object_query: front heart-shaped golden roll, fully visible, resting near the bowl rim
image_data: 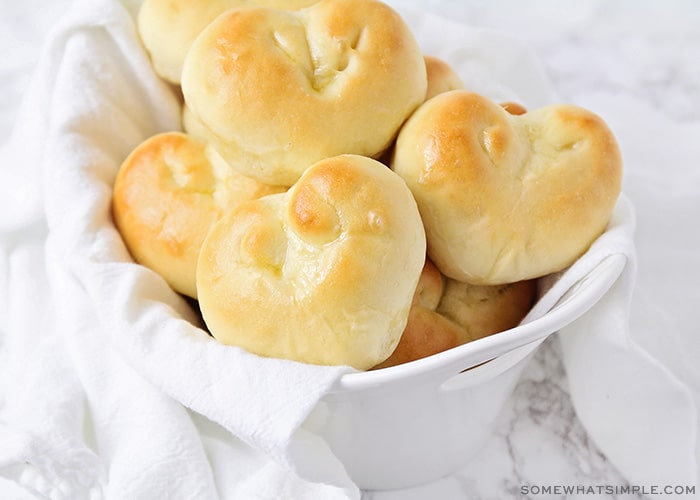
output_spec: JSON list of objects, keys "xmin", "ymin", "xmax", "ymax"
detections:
[{"xmin": 197, "ymin": 155, "xmax": 425, "ymax": 370}]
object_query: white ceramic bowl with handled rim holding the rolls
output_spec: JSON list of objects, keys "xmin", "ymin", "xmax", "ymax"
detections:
[{"xmin": 305, "ymin": 255, "xmax": 626, "ymax": 489}]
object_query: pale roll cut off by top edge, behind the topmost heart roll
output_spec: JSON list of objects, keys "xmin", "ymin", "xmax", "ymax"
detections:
[{"xmin": 137, "ymin": 0, "xmax": 318, "ymax": 84}]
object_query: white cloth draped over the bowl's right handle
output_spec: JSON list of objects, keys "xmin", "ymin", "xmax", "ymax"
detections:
[{"xmin": 523, "ymin": 195, "xmax": 697, "ymax": 498}]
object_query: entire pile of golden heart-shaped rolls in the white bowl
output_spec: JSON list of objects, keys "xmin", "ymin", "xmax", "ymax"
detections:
[{"xmin": 112, "ymin": 0, "xmax": 622, "ymax": 370}]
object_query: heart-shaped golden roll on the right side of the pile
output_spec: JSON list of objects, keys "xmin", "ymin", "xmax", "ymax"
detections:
[{"xmin": 392, "ymin": 90, "xmax": 622, "ymax": 285}]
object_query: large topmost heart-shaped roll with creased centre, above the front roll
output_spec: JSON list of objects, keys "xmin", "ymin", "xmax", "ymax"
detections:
[{"xmin": 182, "ymin": 0, "xmax": 427, "ymax": 186}]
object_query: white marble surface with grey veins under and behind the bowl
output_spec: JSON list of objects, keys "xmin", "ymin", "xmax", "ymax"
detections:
[{"xmin": 0, "ymin": 0, "xmax": 700, "ymax": 500}]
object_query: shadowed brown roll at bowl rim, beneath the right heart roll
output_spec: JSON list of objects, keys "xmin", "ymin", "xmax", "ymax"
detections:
[{"xmin": 375, "ymin": 259, "xmax": 537, "ymax": 369}]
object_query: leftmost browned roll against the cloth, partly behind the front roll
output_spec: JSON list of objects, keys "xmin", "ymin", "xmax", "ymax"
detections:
[{"xmin": 112, "ymin": 132, "xmax": 282, "ymax": 298}]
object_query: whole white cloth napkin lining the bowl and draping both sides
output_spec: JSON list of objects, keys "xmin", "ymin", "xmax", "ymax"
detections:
[{"xmin": 0, "ymin": 0, "xmax": 695, "ymax": 500}]
